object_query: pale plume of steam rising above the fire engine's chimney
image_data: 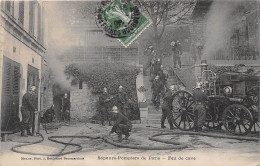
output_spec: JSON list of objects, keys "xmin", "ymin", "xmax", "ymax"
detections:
[{"xmin": 202, "ymin": 0, "xmax": 240, "ymax": 59}]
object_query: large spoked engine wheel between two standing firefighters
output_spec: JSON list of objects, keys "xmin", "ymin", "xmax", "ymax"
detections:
[{"xmin": 172, "ymin": 90, "xmax": 194, "ymax": 131}]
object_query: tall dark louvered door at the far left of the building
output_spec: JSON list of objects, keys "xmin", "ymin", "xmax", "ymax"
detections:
[{"xmin": 1, "ymin": 57, "xmax": 21, "ymax": 131}]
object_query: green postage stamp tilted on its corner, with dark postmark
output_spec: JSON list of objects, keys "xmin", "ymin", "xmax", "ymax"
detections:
[{"xmin": 96, "ymin": 0, "xmax": 152, "ymax": 47}]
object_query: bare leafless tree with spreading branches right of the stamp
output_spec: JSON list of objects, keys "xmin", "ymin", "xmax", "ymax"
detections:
[{"xmin": 135, "ymin": 0, "xmax": 196, "ymax": 50}]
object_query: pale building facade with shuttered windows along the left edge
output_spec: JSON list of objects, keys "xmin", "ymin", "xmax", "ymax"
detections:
[{"xmin": 0, "ymin": 0, "xmax": 46, "ymax": 131}]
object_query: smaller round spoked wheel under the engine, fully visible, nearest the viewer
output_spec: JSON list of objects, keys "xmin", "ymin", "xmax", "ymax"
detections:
[{"xmin": 222, "ymin": 104, "xmax": 253, "ymax": 135}]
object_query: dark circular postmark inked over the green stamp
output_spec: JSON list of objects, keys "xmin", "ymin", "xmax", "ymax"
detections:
[{"xmin": 96, "ymin": 0, "xmax": 140, "ymax": 38}]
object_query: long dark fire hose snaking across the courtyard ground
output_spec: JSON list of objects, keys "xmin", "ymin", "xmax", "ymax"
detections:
[{"xmin": 11, "ymin": 127, "xmax": 260, "ymax": 156}]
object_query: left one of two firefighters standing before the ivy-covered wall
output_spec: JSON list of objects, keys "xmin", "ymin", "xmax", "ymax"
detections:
[{"xmin": 99, "ymin": 87, "xmax": 112, "ymax": 126}]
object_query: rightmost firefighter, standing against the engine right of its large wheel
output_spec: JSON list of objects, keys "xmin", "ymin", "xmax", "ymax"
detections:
[{"xmin": 193, "ymin": 82, "xmax": 209, "ymax": 131}]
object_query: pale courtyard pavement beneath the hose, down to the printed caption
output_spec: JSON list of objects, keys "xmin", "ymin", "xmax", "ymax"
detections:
[{"xmin": 0, "ymin": 122, "xmax": 260, "ymax": 166}]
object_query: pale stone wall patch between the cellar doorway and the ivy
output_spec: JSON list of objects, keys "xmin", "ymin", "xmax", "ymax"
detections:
[{"xmin": 70, "ymin": 82, "xmax": 98, "ymax": 121}]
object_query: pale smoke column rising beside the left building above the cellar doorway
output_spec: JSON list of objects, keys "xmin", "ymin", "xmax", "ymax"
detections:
[{"xmin": 45, "ymin": 1, "xmax": 73, "ymax": 90}]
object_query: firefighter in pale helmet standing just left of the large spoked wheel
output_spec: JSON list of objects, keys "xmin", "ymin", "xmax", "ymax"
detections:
[{"xmin": 161, "ymin": 85, "xmax": 175, "ymax": 130}]
